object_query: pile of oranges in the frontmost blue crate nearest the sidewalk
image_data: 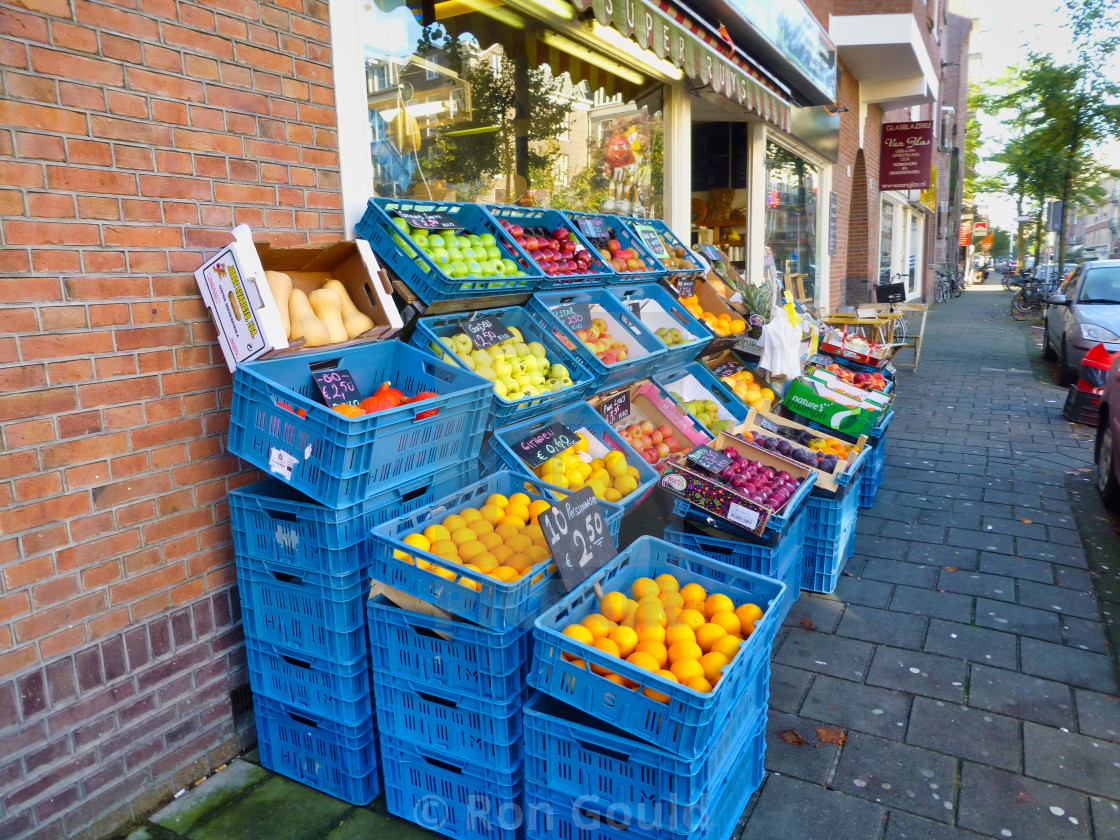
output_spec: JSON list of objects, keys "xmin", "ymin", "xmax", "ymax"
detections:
[{"xmin": 563, "ymin": 573, "xmax": 763, "ymax": 703}]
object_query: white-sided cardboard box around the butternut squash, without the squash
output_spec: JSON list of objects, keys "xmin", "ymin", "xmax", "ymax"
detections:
[{"xmin": 195, "ymin": 225, "xmax": 403, "ymax": 371}]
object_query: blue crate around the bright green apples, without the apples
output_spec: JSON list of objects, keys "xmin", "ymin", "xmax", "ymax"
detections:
[{"xmin": 354, "ymin": 198, "xmax": 543, "ymax": 306}]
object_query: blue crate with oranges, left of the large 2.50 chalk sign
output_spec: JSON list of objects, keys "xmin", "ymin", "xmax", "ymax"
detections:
[{"xmin": 371, "ymin": 469, "xmax": 623, "ymax": 631}]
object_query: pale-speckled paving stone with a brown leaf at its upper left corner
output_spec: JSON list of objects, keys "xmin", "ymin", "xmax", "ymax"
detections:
[{"xmin": 832, "ymin": 732, "xmax": 956, "ymax": 822}]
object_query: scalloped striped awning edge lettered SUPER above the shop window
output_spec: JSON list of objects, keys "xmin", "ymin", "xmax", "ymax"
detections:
[{"xmin": 572, "ymin": 0, "xmax": 792, "ymax": 131}]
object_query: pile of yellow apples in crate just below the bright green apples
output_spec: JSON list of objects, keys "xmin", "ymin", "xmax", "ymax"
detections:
[{"xmin": 439, "ymin": 326, "xmax": 573, "ymax": 402}]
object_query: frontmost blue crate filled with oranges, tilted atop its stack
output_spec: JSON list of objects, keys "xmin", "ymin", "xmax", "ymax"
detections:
[{"xmin": 529, "ymin": 536, "xmax": 785, "ymax": 758}]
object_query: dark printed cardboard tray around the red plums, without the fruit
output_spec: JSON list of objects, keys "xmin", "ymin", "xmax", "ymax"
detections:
[{"xmin": 659, "ymin": 432, "xmax": 818, "ymax": 536}]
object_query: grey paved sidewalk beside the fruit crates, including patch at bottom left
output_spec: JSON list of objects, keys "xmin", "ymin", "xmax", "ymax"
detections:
[{"xmin": 118, "ymin": 283, "xmax": 1120, "ymax": 840}]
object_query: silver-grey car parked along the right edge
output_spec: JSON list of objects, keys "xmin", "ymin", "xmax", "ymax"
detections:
[{"xmin": 1043, "ymin": 260, "xmax": 1120, "ymax": 385}]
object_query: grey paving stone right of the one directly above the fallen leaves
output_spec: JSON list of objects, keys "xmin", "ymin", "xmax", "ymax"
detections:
[{"xmin": 906, "ymin": 697, "xmax": 1023, "ymax": 773}]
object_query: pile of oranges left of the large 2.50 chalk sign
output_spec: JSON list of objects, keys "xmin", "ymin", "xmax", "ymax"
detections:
[{"xmin": 393, "ymin": 493, "xmax": 552, "ymax": 591}]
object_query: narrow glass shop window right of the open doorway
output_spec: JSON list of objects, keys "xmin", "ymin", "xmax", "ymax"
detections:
[{"xmin": 766, "ymin": 142, "xmax": 819, "ymax": 302}]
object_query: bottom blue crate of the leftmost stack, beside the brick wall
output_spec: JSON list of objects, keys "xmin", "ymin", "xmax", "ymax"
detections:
[{"xmin": 253, "ymin": 694, "xmax": 381, "ymax": 805}]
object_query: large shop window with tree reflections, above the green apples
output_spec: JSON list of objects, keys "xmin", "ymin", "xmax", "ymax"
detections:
[{"xmin": 363, "ymin": 0, "xmax": 664, "ymax": 217}]
